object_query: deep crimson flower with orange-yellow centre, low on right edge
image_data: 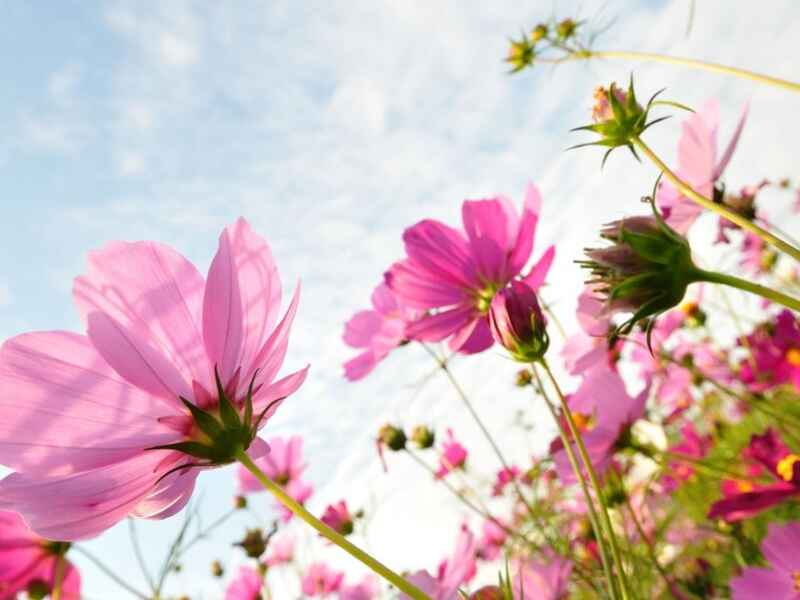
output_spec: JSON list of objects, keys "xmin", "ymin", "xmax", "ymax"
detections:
[{"xmin": 708, "ymin": 429, "xmax": 800, "ymax": 522}]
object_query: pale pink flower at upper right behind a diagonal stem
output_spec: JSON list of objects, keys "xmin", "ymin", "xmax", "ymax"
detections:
[{"xmin": 656, "ymin": 100, "xmax": 748, "ymax": 234}]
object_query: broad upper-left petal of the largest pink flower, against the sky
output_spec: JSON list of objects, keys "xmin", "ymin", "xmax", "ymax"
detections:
[{"xmin": 73, "ymin": 242, "xmax": 209, "ymax": 392}]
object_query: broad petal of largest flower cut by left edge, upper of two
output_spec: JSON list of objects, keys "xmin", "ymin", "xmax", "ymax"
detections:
[{"xmin": 0, "ymin": 331, "xmax": 180, "ymax": 475}]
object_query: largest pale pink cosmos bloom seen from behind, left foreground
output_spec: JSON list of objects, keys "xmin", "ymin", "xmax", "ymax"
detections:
[{"xmin": 0, "ymin": 219, "xmax": 307, "ymax": 540}]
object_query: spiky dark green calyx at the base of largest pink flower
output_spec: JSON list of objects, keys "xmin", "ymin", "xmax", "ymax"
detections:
[{"xmin": 150, "ymin": 369, "xmax": 274, "ymax": 467}]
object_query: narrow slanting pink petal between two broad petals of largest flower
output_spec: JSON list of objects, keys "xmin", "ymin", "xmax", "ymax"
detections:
[{"xmin": 86, "ymin": 312, "xmax": 191, "ymax": 405}]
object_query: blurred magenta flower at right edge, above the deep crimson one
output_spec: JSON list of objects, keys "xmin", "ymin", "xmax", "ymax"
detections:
[{"xmin": 739, "ymin": 309, "xmax": 800, "ymax": 391}]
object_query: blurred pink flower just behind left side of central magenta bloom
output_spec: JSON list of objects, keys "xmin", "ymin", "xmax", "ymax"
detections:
[{"xmin": 343, "ymin": 283, "xmax": 417, "ymax": 381}]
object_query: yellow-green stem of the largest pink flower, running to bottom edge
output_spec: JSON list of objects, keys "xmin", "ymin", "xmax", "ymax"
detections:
[{"xmin": 236, "ymin": 448, "xmax": 431, "ymax": 600}]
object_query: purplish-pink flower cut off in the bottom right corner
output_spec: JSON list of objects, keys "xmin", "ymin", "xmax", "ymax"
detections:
[{"xmin": 731, "ymin": 523, "xmax": 800, "ymax": 600}]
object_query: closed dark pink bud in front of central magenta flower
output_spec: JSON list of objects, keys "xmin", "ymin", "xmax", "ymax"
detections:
[{"xmin": 489, "ymin": 281, "xmax": 550, "ymax": 363}]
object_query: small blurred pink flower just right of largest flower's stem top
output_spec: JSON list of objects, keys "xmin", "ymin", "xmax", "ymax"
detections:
[{"xmin": 237, "ymin": 435, "xmax": 314, "ymax": 522}]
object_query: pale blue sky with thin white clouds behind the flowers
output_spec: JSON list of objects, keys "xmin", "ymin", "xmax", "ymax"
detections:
[{"xmin": 0, "ymin": 0, "xmax": 800, "ymax": 598}]
